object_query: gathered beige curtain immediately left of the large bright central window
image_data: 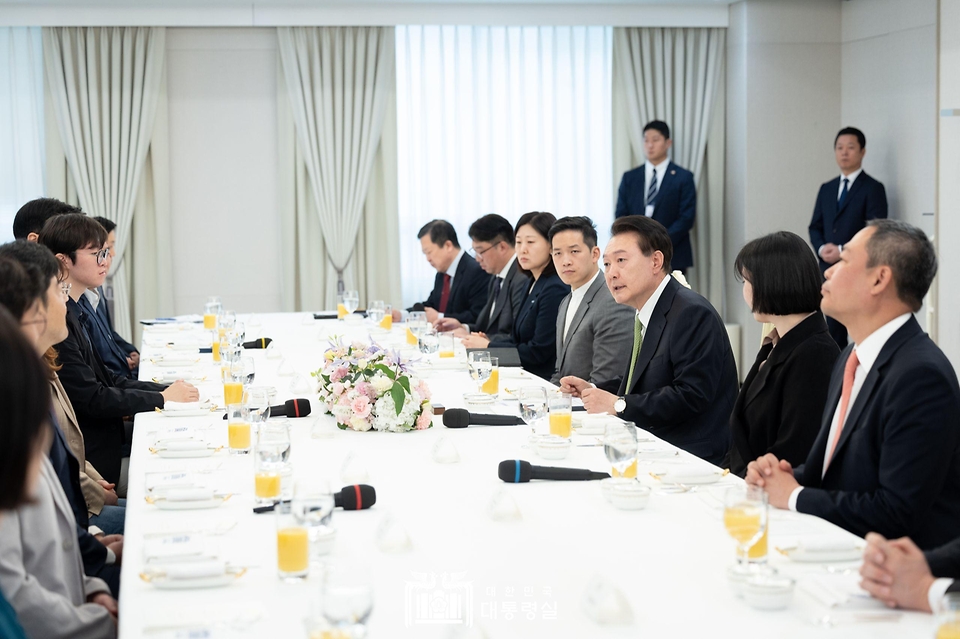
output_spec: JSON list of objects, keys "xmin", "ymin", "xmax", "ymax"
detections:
[{"xmin": 277, "ymin": 27, "xmax": 395, "ymax": 308}]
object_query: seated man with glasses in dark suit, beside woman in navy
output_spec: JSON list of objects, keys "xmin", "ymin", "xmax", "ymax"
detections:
[{"xmin": 437, "ymin": 213, "xmax": 530, "ymax": 342}]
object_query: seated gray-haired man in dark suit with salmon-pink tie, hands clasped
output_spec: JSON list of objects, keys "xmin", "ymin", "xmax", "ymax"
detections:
[{"xmin": 746, "ymin": 220, "xmax": 960, "ymax": 549}]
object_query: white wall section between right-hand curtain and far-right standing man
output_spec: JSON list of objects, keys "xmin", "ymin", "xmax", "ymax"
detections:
[{"xmin": 724, "ymin": 0, "xmax": 840, "ymax": 364}]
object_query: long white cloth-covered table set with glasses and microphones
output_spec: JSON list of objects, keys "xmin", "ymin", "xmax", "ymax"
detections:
[{"xmin": 120, "ymin": 313, "xmax": 934, "ymax": 639}]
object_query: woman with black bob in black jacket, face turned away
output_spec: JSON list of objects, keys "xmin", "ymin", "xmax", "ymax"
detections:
[{"xmin": 726, "ymin": 231, "xmax": 840, "ymax": 477}]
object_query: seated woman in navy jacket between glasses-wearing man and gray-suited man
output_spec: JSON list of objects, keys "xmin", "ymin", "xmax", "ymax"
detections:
[{"xmin": 463, "ymin": 211, "xmax": 570, "ymax": 379}]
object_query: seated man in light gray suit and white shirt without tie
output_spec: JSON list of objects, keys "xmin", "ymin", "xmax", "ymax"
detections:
[{"xmin": 550, "ymin": 216, "xmax": 633, "ymax": 392}]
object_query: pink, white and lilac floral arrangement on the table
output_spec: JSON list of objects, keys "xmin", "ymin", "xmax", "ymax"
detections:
[{"xmin": 311, "ymin": 338, "xmax": 433, "ymax": 433}]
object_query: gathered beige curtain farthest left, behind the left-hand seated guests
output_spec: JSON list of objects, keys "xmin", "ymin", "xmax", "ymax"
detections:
[{"xmin": 43, "ymin": 27, "xmax": 165, "ymax": 337}]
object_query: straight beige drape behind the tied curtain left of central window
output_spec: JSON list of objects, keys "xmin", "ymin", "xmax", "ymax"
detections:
[{"xmin": 277, "ymin": 44, "xmax": 401, "ymax": 311}]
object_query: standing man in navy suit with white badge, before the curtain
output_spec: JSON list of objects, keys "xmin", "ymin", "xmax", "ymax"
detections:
[{"xmin": 616, "ymin": 120, "xmax": 697, "ymax": 272}]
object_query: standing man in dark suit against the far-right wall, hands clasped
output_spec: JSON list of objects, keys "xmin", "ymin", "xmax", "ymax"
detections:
[{"xmin": 810, "ymin": 127, "xmax": 887, "ymax": 350}]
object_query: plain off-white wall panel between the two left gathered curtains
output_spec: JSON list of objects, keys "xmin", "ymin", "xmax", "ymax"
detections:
[{"xmin": 167, "ymin": 28, "xmax": 280, "ymax": 313}]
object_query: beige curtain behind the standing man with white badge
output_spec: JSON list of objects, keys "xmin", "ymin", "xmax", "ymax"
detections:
[{"xmin": 612, "ymin": 27, "xmax": 726, "ymax": 311}]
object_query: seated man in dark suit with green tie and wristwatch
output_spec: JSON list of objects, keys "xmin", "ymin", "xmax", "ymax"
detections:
[{"xmin": 560, "ymin": 215, "xmax": 737, "ymax": 464}]
